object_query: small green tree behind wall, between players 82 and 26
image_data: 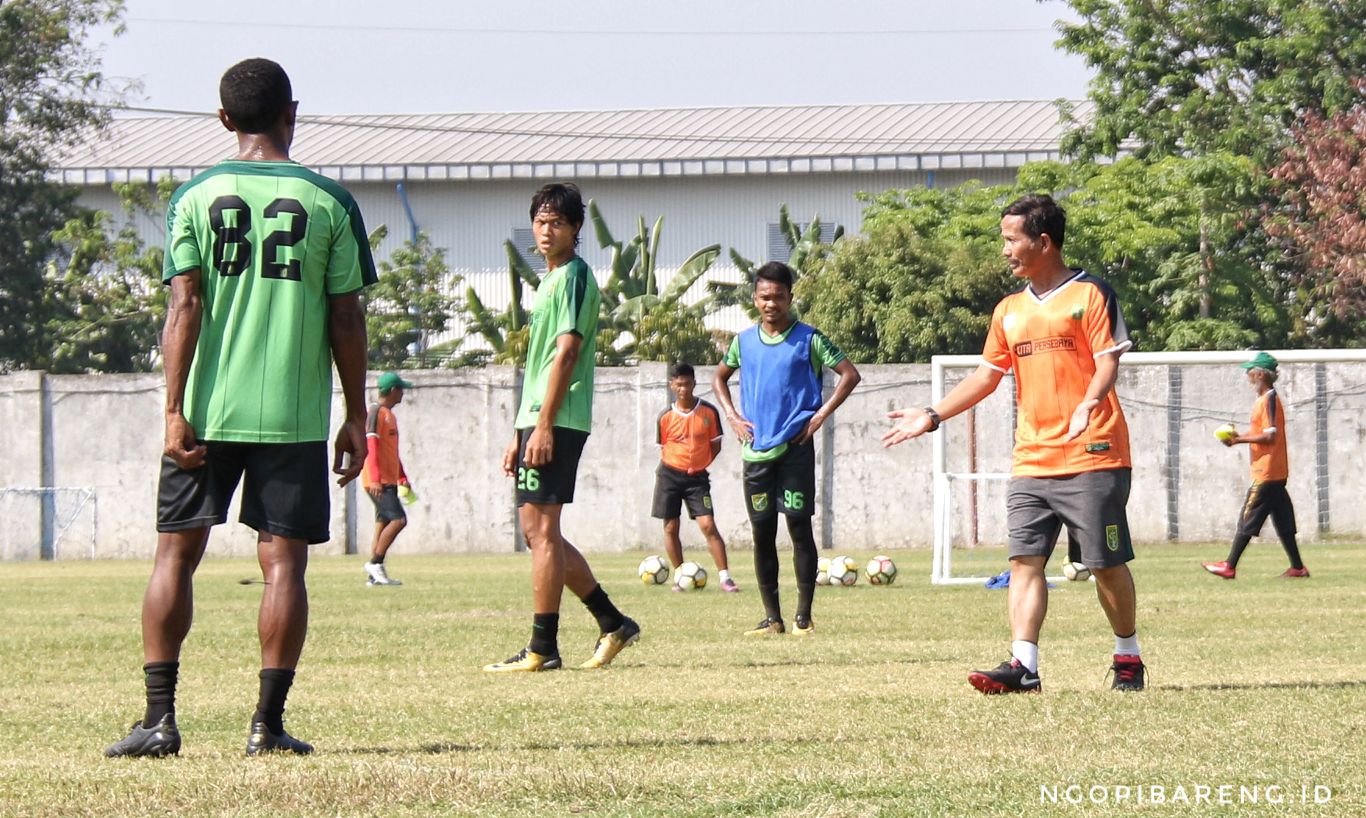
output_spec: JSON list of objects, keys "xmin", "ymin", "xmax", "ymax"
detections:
[{"xmin": 365, "ymin": 225, "xmax": 460, "ymax": 369}]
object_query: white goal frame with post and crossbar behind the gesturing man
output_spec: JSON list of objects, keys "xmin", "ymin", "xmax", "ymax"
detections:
[{"xmin": 930, "ymin": 350, "xmax": 1366, "ymax": 584}]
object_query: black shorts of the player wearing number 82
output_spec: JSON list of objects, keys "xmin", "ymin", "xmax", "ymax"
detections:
[{"xmin": 157, "ymin": 440, "xmax": 332, "ymax": 544}]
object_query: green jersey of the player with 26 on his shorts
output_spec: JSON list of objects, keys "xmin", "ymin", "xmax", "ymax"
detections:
[{"xmin": 515, "ymin": 257, "xmax": 602, "ymax": 432}]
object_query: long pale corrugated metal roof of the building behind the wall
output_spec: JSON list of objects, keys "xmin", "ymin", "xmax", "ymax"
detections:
[{"xmin": 56, "ymin": 101, "xmax": 1090, "ymax": 184}]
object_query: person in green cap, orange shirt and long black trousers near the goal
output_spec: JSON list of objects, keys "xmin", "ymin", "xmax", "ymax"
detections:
[{"xmin": 1202, "ymin": 352, "xmax": 1309, "ymax": 579}]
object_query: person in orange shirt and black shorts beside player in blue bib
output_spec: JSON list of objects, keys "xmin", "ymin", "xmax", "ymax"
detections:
[{"xmin": 650, "ymin": 363, "xmax": 740, "ymax": 594}]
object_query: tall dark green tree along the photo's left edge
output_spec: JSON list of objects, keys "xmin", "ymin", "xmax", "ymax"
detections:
[{"xmin": 0, "ymin": 0, "xmax": 123, "ymax": 371}]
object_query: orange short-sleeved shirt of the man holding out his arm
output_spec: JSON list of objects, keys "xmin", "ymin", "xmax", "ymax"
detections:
[{"xmin": 982, "ymin": 270, "xmax": 1132, "ymax": 477}]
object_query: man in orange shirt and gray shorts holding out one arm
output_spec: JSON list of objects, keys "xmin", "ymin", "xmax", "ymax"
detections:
[{"xmin": 882, "ymin": 195, "xmax": 1145, "ymax": 694}]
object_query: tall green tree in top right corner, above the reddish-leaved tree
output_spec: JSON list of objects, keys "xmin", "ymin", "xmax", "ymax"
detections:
[{"xmin": 1057, "ymin": 0, "xmax": 1366, "ymax": 161}]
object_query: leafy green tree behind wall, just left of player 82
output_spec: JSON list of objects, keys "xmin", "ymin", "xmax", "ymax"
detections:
[{"xmin": 41, "ymin": 179, "xmax": 178, "ymax": 373}]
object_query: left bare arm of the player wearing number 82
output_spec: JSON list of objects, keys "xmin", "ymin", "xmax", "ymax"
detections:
[{"xmin": 161, "ymin": 270, "xmax": 208, "ymax": 468}]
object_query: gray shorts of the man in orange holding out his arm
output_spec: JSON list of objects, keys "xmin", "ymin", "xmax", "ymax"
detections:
[{"xmin": 1005, "ymin": 468, "xmax": 1134, "ymax": 568}]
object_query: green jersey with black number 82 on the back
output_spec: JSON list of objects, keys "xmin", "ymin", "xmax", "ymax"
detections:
[{"xmin": 163, "ymin": 161, "xmax": 376, "ymax": 442}]
